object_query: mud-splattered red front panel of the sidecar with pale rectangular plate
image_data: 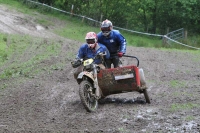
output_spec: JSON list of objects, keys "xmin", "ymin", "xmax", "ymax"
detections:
[{"xmin": 98, "ymin": 66, "xmax": 140, "ymax": 96}]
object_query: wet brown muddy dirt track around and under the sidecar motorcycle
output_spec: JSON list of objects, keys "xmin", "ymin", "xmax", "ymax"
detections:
[{"xmin": 0, "ymin": 5, "xmax": 200, "ymax": 133}]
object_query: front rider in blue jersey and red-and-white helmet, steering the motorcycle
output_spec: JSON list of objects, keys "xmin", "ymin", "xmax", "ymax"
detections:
[{"xmin": 74, "ymin": 32, "xmax": 110, "ymax": 79}]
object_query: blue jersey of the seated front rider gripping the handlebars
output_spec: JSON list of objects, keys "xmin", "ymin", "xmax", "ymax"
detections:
[{"xmin": 77, "ymin": 43, "xmax": 110, "ymax": 64}]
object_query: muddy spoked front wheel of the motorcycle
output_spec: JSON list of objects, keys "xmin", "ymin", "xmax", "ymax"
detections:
[{"xmin": 79, "ymin": 80, "xmax": 98, "ymax": 112}]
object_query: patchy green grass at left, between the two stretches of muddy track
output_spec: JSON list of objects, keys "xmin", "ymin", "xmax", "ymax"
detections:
[{"xmin": 0, "ymin": 34, "xmax": 64, "ymax": 79}]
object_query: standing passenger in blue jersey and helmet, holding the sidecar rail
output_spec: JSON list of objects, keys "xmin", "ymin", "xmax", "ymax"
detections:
[{"xmin": 97, "ymin": 19, "xmax": 127, "ymax": 68}]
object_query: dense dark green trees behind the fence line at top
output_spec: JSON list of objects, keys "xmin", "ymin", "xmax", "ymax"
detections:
[{"xmin": 29, "ymin": 0, "xmax": 200, "ymax": 34}]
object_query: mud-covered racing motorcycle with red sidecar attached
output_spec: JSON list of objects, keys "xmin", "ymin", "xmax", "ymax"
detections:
[{"xmin": 71, "ymin": 54, "xmax": 150, "ymax": 112}]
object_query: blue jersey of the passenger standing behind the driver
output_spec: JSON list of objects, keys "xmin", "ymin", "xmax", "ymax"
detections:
[{"xmin": 97, "ymin": 30, "xmax": 126, "ymax": 57}]
